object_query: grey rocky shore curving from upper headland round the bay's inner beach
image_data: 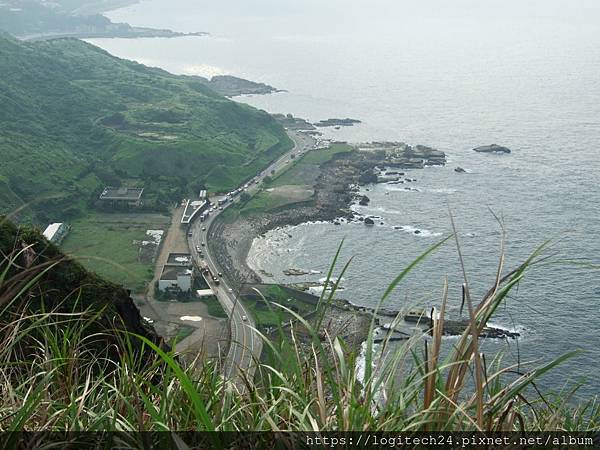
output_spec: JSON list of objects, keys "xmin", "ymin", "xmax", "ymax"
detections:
[{"xmin": 209, "ymin": 137, "xmax": 446, "ymax": 286}]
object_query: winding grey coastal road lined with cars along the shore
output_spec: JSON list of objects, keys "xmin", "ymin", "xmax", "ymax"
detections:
[{"xmin": 187, "ymin": 132, "xmax": 313, "ymax": 389}]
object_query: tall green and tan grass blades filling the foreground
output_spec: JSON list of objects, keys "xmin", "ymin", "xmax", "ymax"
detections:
[{"xmin": 0, "ymin": 229, "xmax": 600, "ymax": 431}]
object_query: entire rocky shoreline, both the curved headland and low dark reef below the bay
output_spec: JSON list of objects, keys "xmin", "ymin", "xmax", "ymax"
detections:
[{"xmin": 209, "ymin": 134, "xmax": 519, "ymax": 341}]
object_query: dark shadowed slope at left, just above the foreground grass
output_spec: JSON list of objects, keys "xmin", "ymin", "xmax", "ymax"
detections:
[{"xmin": 0, "ymin": 217, "xmax": 164, "ymax": 361}]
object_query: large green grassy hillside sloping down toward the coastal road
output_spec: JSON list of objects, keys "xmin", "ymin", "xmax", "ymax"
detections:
[{"xmin": 0, "ymin": 35, "xmax": 291, "ymax": 222}]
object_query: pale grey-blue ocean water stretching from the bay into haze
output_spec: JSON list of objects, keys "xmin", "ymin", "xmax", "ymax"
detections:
[{"xmin": 91, "ymin": 0, "xmax": 600, "ymax": 398}]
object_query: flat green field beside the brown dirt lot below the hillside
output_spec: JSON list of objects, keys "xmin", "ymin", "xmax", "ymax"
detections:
[{"xmin": 61, "ymin": 214, "xmax": 169, "ymax": 292}]
